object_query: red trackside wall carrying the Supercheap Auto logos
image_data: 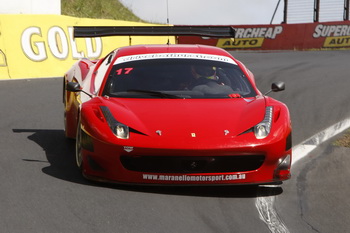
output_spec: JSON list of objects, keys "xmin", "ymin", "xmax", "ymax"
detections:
[{"xmin": 179, "ymin": 21, "xmax": 350, "ymax": 50}]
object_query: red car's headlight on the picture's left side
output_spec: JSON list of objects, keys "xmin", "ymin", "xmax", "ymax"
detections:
[{"xmin": 100, "ymin": 106, "xmax": 129, "ymax": 139}]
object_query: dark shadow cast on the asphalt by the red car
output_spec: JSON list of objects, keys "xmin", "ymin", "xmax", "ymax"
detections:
[{"xmin": 13, "ymin": 129, "xmax": 283, "ymax": 198}]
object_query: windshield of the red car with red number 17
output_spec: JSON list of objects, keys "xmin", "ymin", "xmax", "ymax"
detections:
[{"xmin": 103, "ymin": 59, "xmax": 256, "ymax": 98}]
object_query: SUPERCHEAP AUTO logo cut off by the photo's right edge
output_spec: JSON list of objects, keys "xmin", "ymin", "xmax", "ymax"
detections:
[{"xmin": 313, "ymin": 24, "xmax": 350, "ymax": 48}]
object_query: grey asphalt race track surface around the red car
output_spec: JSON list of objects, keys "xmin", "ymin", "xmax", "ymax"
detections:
[{"xmin": 0, "ymin": 51, "xmax": 350, "ymax": 233}]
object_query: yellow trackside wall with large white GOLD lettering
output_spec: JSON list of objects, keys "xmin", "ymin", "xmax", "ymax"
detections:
[{"xmin": 0, "ymin": 14, "xmax": 175, "ymax": 80}]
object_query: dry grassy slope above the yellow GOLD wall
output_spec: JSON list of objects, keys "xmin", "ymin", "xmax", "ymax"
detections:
[{"xmin": 61, "ymin": 0, "xmax": 144, "ymax": 22}]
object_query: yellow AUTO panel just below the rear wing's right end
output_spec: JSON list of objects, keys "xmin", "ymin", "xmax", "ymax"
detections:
[{"xmin": 216, "ymin": 37, "xmax": 264, "ymax": 49}]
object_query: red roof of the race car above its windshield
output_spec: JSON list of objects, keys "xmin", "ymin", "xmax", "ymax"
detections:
[{"xmin": 118, "ymin": 44, "xmax": 235, "ymax": 57}]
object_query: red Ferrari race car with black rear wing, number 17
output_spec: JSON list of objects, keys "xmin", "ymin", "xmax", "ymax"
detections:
[{"xmin": 64, "ymin": 27, "xmax": 292, "ymax": 185}]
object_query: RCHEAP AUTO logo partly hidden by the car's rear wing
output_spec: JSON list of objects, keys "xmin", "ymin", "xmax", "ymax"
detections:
[{"xmin": 216, "ymin": 26, "xmax": 283, "ymax": 49}]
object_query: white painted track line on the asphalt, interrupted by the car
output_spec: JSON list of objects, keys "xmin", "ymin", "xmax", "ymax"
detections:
[{"xmin": 255, "ymin": 118, "xmax": 350, "ymax": 233}]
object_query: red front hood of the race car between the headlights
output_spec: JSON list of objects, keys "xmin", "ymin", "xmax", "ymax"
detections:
[{"xmin": 105, "ymin": 97, "xmax": 265, "ymax": 138}]
